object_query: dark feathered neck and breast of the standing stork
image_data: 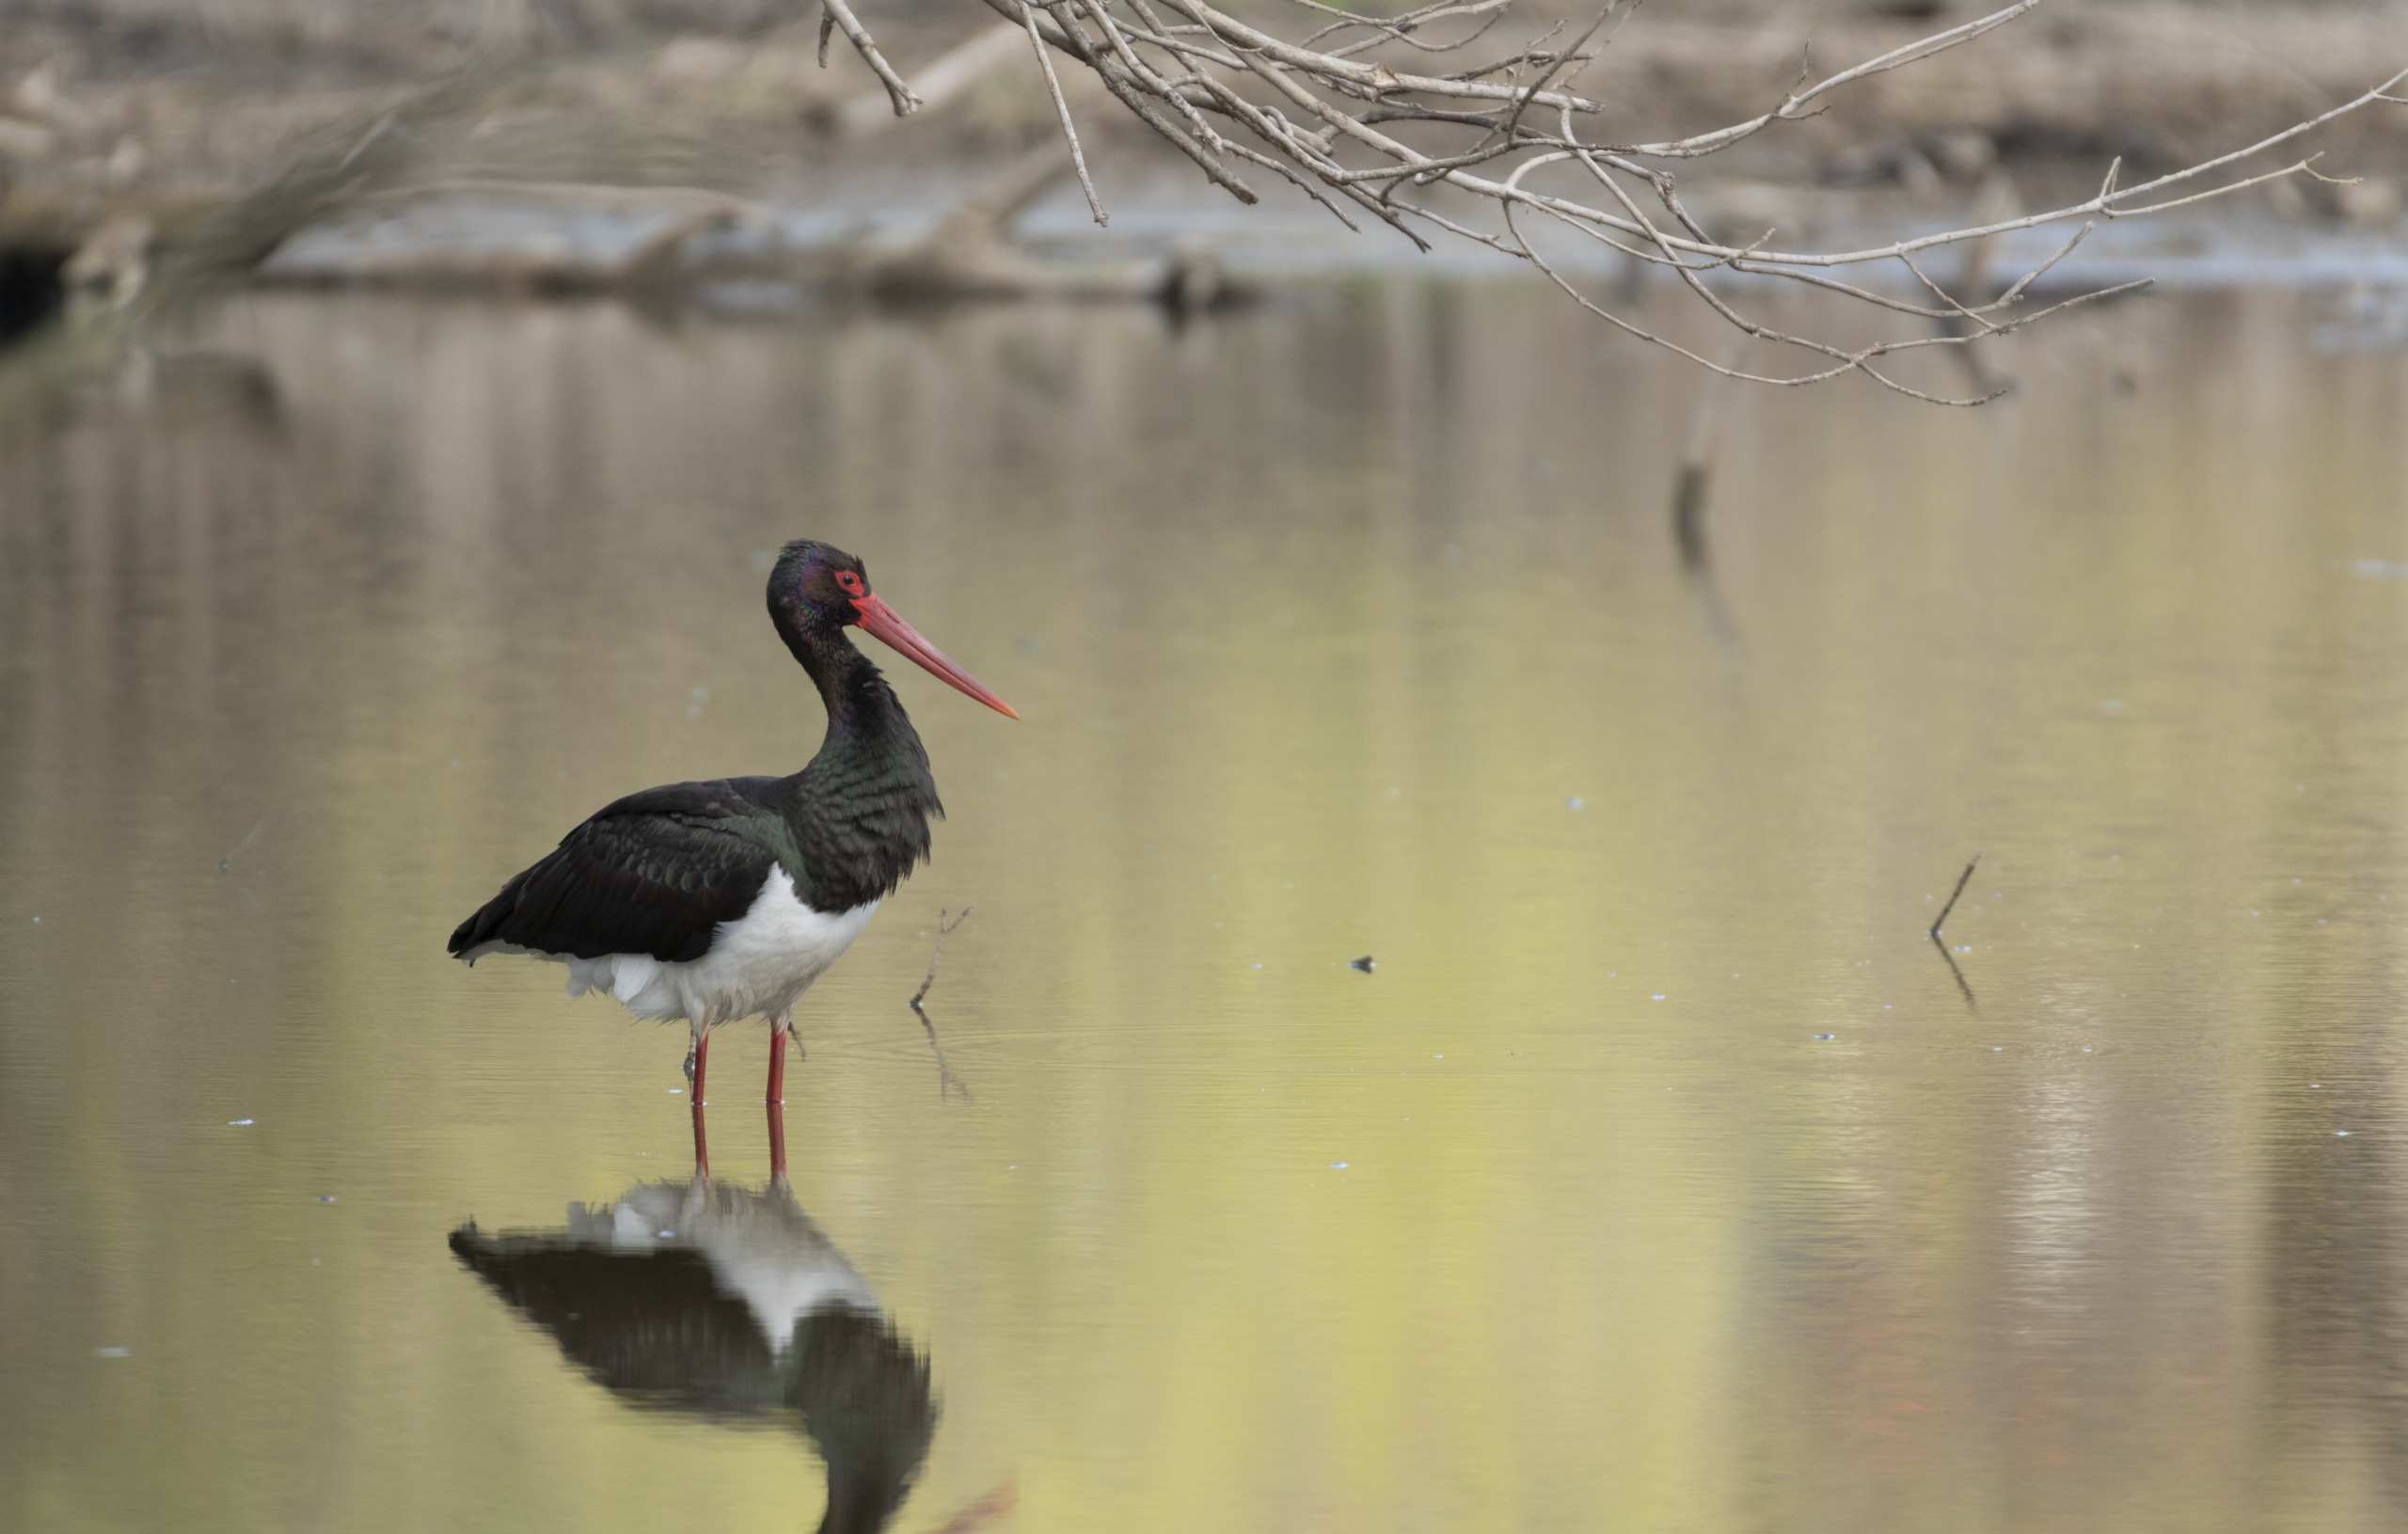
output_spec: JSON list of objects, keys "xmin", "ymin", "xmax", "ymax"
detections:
[{"xmin": 780, "ymin": 624, "xmax": 944, "ymax": 910}]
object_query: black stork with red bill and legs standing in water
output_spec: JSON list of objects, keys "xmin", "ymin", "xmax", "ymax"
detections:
[{"xmin": 451, "ymin": 540, "xmax": 1021, "ymax": 1112}]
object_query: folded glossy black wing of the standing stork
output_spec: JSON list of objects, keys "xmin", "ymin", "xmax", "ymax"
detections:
[{"xmin": 451, "ymin": 778, "xmax": 800, "ymax": 961}]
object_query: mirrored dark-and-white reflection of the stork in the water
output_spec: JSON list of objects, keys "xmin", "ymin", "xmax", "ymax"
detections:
[{"xmin": 451, "ymin": 1108, "xmax": 937, "ymax": 1534}]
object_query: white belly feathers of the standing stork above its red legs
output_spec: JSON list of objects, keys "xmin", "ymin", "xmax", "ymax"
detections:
[{"xmin": 551, "ymin": 867, "xmax": 879, "ymax": 1028}]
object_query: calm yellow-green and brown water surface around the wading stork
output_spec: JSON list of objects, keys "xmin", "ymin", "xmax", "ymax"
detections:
[{"xmin": 0, "ymin": 284, "xmax": 2408, "ymax": 1534}]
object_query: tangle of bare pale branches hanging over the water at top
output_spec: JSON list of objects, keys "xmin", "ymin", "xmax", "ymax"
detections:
[{"xmin": 934, "ymin": 0, "xmax": 2408, "ymax": 404}]
